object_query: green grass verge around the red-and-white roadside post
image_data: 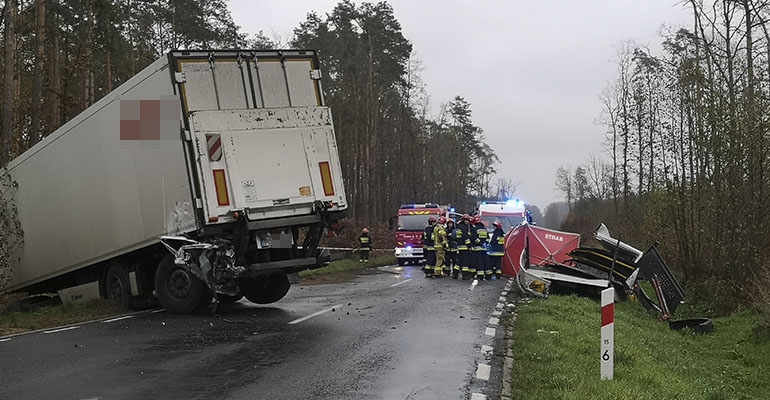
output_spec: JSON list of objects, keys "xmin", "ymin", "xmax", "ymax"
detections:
[{"xmin": 509, "ymin": 296, "xmax": 770, "ymax": 400}]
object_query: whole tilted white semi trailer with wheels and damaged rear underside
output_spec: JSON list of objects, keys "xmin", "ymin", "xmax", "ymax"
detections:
[{"xmin": 6, "ymin": 50, "xmax": 347, "ymax": 313}]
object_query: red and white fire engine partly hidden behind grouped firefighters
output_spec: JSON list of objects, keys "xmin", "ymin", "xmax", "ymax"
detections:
[{"xmin": 396, "ymin": 203, "xmax": 449, "ymax": 265}]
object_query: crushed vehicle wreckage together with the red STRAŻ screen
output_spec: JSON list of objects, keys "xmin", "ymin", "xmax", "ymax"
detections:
[{"xmin": 503, "ymin": 224, "xmax": 713, "ymax": 333}]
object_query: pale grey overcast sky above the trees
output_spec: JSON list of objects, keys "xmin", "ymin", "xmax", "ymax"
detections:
[{"xmin": 228, "ymin": 0, "xmax": 692, "ymax": 210}]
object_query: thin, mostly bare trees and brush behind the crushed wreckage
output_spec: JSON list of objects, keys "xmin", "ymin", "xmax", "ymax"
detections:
[{"xmin": 546, "ymin": 0, "xmax": 770, "ymax": 321}]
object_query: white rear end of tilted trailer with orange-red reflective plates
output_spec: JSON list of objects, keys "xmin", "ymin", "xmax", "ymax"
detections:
[{"xmin": 175, "ymin": 52, "xmax": 345, "ymax": 223}]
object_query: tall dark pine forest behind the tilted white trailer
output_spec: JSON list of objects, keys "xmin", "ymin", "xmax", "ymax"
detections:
[{"xmin": 0, "ymin": 0, "xmax": 498, "ymax": 223}]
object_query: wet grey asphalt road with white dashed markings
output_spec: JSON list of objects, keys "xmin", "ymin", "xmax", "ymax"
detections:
[{"xmin": 0, "ymin": 267, "xmax": 507, "ymax": 400}]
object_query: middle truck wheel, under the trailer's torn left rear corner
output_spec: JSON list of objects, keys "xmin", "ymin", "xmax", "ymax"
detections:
[{"xmin": 155, "ymin": 255, "xmax": 204, "ymax": 314}]
